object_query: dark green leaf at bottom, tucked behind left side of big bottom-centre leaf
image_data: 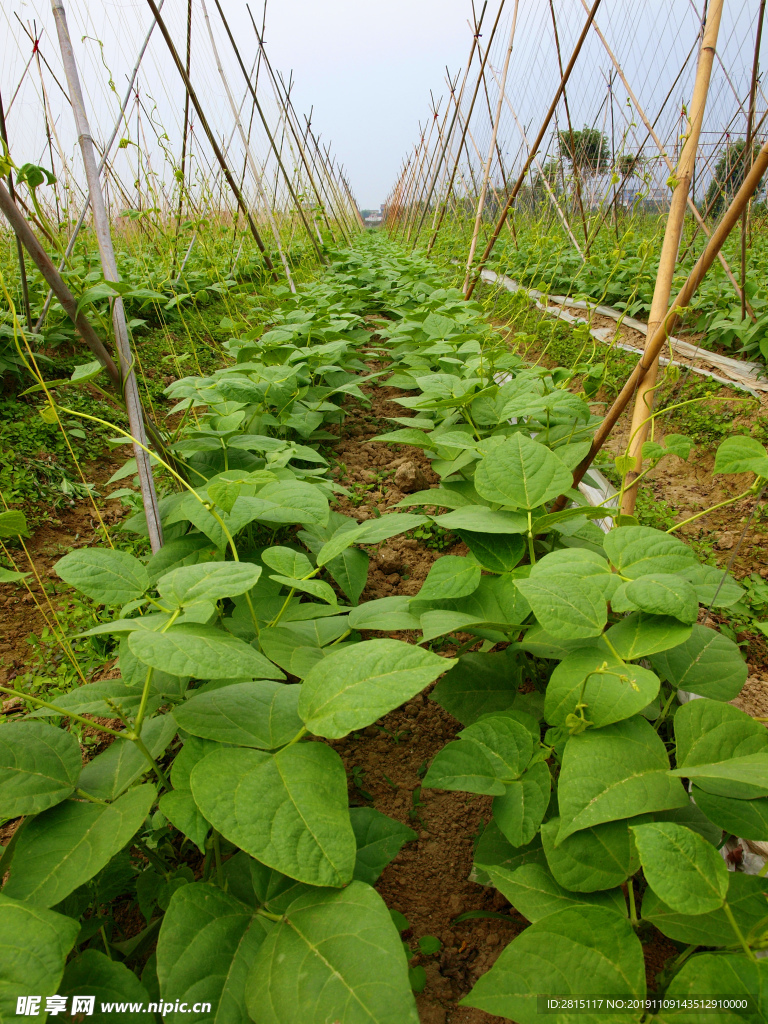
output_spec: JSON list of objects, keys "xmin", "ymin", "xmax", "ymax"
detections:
[{"xmin": 158, "ymin": 882, "xmax": 271, "ymax": 1024}]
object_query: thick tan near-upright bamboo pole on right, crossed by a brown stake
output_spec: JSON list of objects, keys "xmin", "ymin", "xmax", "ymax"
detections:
[{"xmin": 622, "ymin": 0, "xmax": 723, "ymax": 515}]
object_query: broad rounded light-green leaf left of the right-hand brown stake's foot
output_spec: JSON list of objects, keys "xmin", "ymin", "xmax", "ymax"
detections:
[{"xmin": 475, "ymin": 433, "xmax": 573, "ymax": 509}]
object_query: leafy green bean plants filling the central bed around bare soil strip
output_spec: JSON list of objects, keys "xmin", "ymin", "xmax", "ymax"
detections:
[{"xmin": 0, "ymin": 240, "xmax": 768, "ymax": 1024}]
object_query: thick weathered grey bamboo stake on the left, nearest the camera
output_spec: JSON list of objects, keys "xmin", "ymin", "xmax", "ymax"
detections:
[{"xmin": 51, "ymin": 0, "xmax": 163, "ymax": 553}]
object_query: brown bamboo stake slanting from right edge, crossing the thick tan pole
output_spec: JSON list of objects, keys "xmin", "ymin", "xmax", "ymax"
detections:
[{"xmin": 551, "ymin": 136, "xmax": 768, "ymax": 512}]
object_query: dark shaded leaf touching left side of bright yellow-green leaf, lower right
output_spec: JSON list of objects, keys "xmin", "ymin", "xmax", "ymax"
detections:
[{"xmin": 542, "ymin": 818, "xmax": 640, "ymax": 893}]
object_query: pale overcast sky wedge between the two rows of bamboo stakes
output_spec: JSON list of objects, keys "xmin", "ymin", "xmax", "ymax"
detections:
[{"xmin": 246, "ymin": 0, "xmax": 472, "ymax": 207}]
